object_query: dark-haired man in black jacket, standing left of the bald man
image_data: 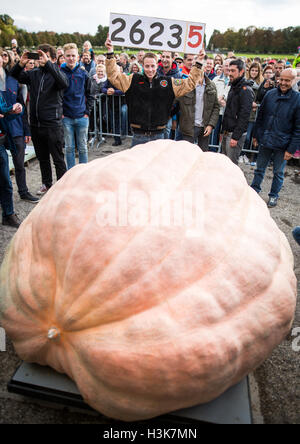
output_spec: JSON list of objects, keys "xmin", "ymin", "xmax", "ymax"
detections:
[{"xmin": 222, "ymin": 59, "xmax": 254, "ymax": 165}]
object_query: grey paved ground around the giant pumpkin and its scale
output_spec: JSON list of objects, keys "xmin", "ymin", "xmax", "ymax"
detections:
[{"xmin": 0, "ymin": 139, "xmax": 300, "ymax": 424}]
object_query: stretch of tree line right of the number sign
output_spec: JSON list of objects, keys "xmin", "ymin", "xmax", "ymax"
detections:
[{"xmin": 208, "ymin": 26, "xmax": 300, "ymax": 54}]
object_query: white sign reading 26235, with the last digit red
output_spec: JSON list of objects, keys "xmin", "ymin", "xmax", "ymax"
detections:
[{"xmin": 109, "ymin": 13, "xmax": 205, "ymax": 54}]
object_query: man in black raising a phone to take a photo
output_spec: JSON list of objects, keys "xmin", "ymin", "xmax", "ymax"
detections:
[{"xmin": 10, "ymin": 44, "xmax": 69, "ymax": 195}]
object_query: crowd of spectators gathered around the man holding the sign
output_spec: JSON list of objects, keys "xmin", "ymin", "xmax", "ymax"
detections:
[{"xmin": 0, "ymin": 40, "xmax": 300, "ymax": 227}]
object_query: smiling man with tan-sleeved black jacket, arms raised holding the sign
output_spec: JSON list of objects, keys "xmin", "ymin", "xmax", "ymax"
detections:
[{"xmin": 105, "ymin": 37, "xmax": 205, "ymax": 146}]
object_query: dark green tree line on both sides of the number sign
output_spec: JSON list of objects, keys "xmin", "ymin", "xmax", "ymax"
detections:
[{"xmin": 0, "ymin": 14, "xmax": 300, "ymax": 54}]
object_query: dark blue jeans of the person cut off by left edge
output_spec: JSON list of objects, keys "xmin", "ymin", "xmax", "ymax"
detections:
[{"xmin": 0, "ymin": 145, "xmax": 14, "ymax": 216}]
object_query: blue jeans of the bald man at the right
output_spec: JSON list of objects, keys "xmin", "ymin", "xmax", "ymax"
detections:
[{"xmin": 251, "ymin": 146, "xmax": 286, "ymax": 197}]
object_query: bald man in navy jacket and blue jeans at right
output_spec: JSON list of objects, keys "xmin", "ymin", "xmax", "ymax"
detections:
[{"xmin": 251, "ymin": 68, "xmax": 300, "ymax": 208}]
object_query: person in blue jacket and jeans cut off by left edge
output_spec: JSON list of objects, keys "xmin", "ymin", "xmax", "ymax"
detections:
[{"xmin": 0, "ymin": 92, "xmax": 22, "ymax": 228}]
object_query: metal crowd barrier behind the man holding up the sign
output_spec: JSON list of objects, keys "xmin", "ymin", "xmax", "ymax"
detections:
[{"xmin": 89, "ymin": 94, "xmax": 259, "ymax": 154}]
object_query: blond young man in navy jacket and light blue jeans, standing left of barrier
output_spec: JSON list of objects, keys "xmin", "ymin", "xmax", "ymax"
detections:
[{"xmin": 61, "ymin": 43, "xmax": 94, "ymax": 170}]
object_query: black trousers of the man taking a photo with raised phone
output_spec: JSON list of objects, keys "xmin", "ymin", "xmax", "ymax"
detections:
[{"xmin": 31, "ymin": 127, "xmax": 67, "ymax": 188}]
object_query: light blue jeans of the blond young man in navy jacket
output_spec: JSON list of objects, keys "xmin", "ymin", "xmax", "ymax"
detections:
[{"xmin": 63, "ymin": 117, "xmax": 89, "ymax": 170}]
